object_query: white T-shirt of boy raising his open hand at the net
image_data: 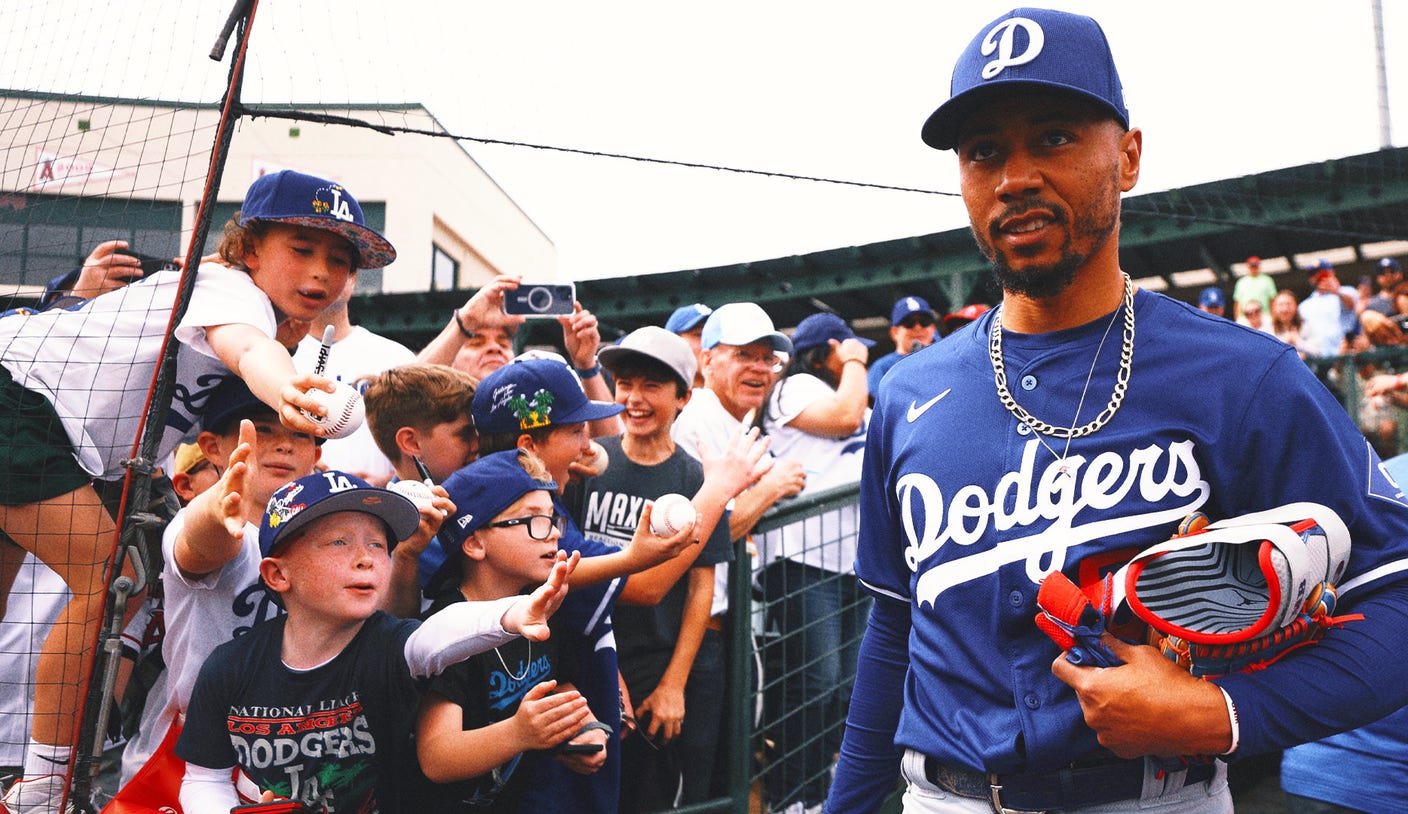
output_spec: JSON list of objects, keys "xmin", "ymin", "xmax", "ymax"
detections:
[{"xmin": 122, "ymin": 508, "xmax": 283, "ymax": 783}]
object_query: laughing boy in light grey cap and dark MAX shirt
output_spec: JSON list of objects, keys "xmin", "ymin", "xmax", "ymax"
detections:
[{"xmin": 565, "ymin": 325, "xmax": 767, "ymax": 814}]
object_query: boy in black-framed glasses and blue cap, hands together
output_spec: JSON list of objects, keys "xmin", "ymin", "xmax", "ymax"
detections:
[{"xmin": 415, "ymin": 449, "xmax": 608, "ymax": 813}]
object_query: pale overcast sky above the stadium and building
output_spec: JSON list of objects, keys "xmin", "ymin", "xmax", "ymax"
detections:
[{"xmin": 0, "ymin": 0, "xmax": 1408, "ymax": 279}]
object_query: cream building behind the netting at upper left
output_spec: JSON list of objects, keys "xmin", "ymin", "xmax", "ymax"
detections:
[{"xmin": 0, "ymin": 90, "xmax": 559, "ymax": 294}]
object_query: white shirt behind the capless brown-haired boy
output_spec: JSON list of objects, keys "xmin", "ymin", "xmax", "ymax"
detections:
[{"xmin": 293, "ymin": 325, "xmax": 415, "ymax": 476}]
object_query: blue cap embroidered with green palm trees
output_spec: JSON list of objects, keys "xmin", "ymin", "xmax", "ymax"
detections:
[{"xmin": 469, "ymin": 358, "xmax": 624, "ymax": 434}]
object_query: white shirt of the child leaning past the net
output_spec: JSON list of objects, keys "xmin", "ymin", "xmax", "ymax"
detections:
[{"xmin": 0, "ymin": 263, "xmax": 277, "ymax": 480}]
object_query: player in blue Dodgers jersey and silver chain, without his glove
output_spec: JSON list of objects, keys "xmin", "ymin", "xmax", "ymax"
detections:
[{"xmin": 826, "ymin": 8, "xmax": 1408, "ymax": 814}]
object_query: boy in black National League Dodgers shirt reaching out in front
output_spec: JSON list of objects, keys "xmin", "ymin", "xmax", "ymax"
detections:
[{"xmin": 176, "ymin": 470, "xmax": 572, "ymax": 814}]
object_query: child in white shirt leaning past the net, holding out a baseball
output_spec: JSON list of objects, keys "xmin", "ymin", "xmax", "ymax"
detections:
[{"xmin": 0, "ymin": 170, "xmax": 396, "ymax": 814}]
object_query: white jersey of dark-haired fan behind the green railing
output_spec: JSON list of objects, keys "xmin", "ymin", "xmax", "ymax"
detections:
[{"xmin": 758, "ymin": 373, "xmax": 870, "ymax": 573}]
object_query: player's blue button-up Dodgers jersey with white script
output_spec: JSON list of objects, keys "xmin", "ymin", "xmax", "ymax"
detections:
[{"xmin": 856, "ymin": 292, "xmax": 1408, "ymax": 772}]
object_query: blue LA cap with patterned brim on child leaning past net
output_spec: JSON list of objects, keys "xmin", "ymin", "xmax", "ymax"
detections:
[{"xmin": 239, "ymin": 169, "xmax": 396, "ymax": 269}]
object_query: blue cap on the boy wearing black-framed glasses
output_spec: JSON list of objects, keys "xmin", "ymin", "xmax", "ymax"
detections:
[{"xmin": 420, "ymin": 449, "xmax": 558, "ymax": 596}]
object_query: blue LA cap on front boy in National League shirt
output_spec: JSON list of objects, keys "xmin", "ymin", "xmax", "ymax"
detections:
[{"xmin": 259, "ymin": 469, "xmax": 421, "ymax": 556}]
